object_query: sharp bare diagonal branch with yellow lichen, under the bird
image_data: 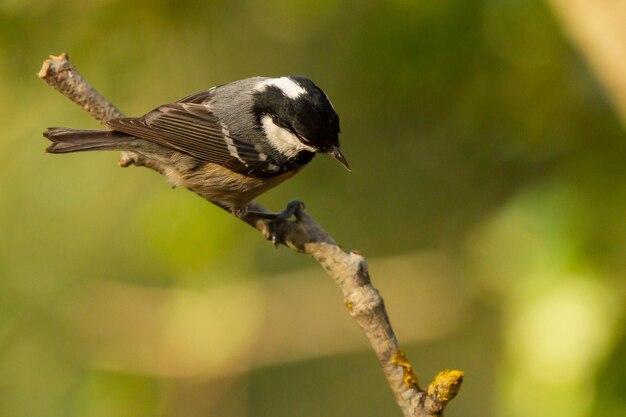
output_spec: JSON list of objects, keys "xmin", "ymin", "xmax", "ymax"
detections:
[{"xmin": 38, "ymin": 54, "xmax": 463, "ymax": 417}]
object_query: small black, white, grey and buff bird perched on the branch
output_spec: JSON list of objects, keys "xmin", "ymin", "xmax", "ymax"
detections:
[{"xmin": 44, "ymin": 75, "xmax": 350, "ymax": 224}]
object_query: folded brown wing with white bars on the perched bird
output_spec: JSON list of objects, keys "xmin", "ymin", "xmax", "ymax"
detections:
[{"xmin": 107, "ymin": 101, "xmax": 277, "ymax": 176}]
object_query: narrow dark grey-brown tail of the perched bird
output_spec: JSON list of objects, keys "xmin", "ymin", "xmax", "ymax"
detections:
[{"xmin": 43, "ymin": 127, "xmax": 137, "ymax": 153}]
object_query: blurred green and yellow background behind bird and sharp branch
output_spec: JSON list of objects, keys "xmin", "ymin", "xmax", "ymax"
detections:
[{"xmin": 0, "ymin": 0, "xmax": 626, "ymax": 417}]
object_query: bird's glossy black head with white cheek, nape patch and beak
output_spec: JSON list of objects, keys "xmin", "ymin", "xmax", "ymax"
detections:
[{"xmin": 253, "ymin": 76, "xmax": 349, "ymax": 169}]
